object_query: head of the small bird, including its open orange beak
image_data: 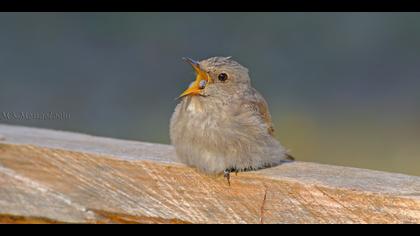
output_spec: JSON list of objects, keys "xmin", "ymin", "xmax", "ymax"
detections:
[{"xmin": 179, "ymin": 57, "xmax": 250, "ymax": 97}]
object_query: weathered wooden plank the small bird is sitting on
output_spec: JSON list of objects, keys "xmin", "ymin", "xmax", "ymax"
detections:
[{"xmin": 0, "ymin": 125, "xmax": 420, "ymax": 223}]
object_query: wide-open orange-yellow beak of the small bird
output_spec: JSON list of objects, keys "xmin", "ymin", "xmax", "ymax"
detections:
[{"xmin": 179, "ymin": 57, "xmax": 212, "ymax": 98}]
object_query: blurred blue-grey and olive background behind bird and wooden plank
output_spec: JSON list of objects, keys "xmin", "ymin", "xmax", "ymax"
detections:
[{"xmin": 0, "ymin": 13, "xmax": 420, "ymax": 175}]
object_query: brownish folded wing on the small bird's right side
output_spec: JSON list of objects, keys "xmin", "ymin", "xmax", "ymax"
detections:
[{"xmin": 240, "ymin": 88, "xmax": 274, "ymax": 135}]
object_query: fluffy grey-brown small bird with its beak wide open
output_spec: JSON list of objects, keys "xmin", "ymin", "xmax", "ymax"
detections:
[{"xmin": 169, "ymin": 56, "xmax": 294, "ymax": 185}]
